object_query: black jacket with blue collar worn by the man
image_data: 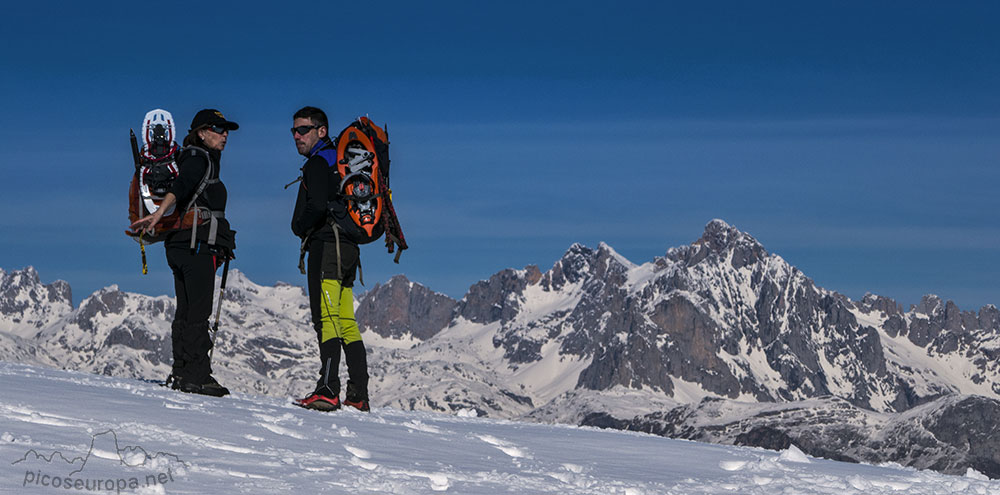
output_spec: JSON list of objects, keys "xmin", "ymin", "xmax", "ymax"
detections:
[{"xmin": 292, "ymin": 138, "xmax": 354, "ymax": 243}]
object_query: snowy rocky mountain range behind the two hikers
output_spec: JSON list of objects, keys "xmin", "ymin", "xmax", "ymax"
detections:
[{"xmin": 0, "ymin": 220, "xmax": 1000, "ymax": 477}]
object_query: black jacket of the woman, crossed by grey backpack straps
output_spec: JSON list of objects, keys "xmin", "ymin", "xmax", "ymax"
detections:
[{"xmin": 164, "ymin": 145, "xmax": 236, "ymax": 250}]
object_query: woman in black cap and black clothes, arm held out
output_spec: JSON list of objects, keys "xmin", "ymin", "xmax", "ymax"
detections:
[{"xmin": 131, "ymin": 109, "xmax": 240, "ymax": 397}]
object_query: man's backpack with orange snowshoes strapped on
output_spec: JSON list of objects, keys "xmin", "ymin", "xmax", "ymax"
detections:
[{"xmin": 329, "ymin": 117, "xmax": 408, "ymax": 263}]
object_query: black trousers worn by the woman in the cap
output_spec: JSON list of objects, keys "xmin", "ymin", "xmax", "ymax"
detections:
[{"xmin": 166, "ymin": 246, "xmax": 215, "ymax": 384}]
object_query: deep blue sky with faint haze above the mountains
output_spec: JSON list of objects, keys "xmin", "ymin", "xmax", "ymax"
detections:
[{"xmin": 0, "ymin": 2, "xmax": 1000, "ymax": 309}]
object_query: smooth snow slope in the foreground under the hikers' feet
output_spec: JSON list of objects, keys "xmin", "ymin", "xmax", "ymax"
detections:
[{"xmin": 0, "ymin": 362, "xmax": 1000, "ymax": 495}]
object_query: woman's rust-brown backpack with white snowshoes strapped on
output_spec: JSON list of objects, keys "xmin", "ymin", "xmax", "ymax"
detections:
[{"xmin": 125, "ymin": 108, "xmax": 212, "ymax": 244}]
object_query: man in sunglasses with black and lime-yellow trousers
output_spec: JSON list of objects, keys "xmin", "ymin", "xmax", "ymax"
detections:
[{"xmin": 291, "ymin": 107, "xmax": 369, "ymax": 411}]
